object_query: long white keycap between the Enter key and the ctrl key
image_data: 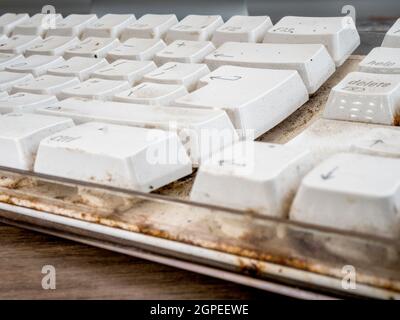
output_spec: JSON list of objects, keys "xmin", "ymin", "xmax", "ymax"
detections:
[{"xmin": 36, "ymin": 98, "xmax": 238, "ymax": 165}]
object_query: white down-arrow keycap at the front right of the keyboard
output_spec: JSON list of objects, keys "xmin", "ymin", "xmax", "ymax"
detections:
[{"xmin": 290, "ymin": 153, "xmax": 400, "ymax": 238}]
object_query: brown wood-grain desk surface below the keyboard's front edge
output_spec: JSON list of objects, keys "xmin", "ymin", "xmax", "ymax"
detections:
[{"xmin": 0, "ymin": 224, "xmax": 282, "ymax": 299}]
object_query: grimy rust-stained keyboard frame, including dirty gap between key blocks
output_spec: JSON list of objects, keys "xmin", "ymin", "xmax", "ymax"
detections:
[{"xmin": 0, "ymin": 56, "xmax": 400, "ymax": 299}]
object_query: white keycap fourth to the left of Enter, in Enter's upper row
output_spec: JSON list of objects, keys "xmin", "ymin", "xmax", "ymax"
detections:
[{"xmin": 6, "ymin": 55, "xmax": 65, "ymax": 77}]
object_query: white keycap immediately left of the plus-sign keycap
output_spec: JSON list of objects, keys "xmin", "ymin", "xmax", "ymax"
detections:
[{"xmin": 107, "ymin": 38, "xmax": 166, "ymax": 61}]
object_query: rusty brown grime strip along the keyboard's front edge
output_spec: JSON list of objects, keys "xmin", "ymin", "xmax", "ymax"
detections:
[{"xmin": 0, "ymin": 184, "xmax": 398, "ymax": 290}]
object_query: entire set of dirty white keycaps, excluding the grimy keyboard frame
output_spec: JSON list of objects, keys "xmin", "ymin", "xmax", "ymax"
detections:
[{"xmin": 0, "ymin": 13, "xmax": 400, "ymax": 242}]
